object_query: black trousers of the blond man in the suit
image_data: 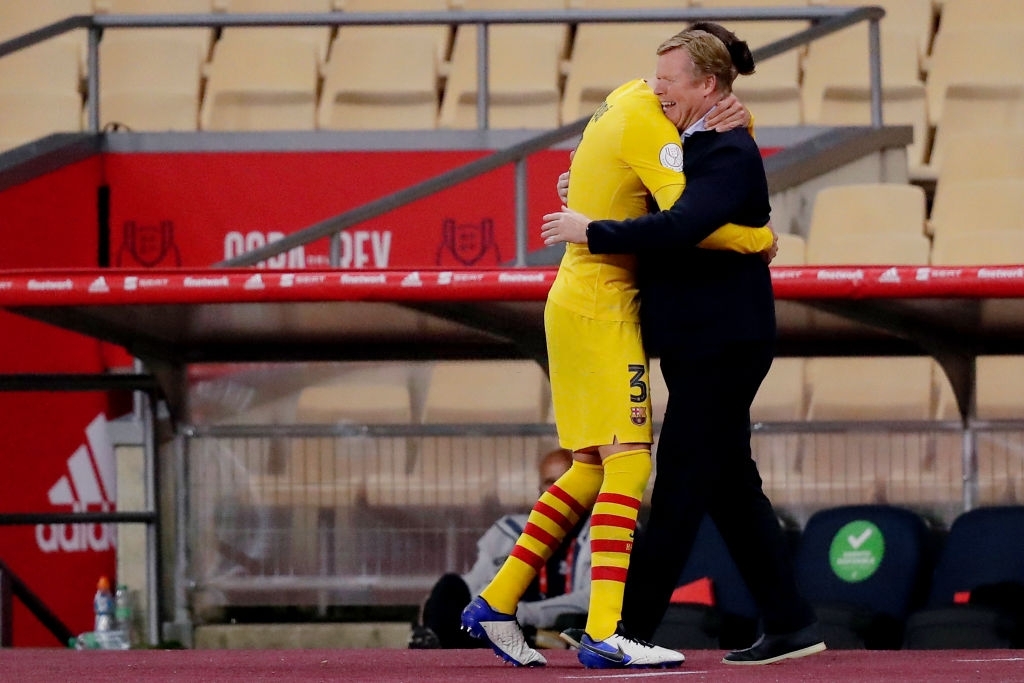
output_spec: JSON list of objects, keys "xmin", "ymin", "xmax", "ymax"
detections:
[{"xmin": 623, "ymin": 341, "xmax": 814, "ymax": 640}]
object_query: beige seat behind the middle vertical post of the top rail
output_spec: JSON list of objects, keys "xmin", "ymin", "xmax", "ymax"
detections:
[{"xmin": 439, "ymin": 0, "xmax": 569, "ymax": 129}]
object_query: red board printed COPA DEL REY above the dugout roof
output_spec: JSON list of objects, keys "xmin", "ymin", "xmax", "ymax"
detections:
[{"xmin": 98, "ymin": 151, "xmax": 568, "ymax": 269}]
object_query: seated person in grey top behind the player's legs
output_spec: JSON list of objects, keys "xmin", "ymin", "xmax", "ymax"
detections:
[{"xmin": 409, "ymin": 449, "xmax": 590, "ymax": 649}]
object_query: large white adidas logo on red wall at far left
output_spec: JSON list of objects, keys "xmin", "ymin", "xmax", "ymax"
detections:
[{"xmin": 36, "ymin": 414, "xmax": 117, "ymax": 553}]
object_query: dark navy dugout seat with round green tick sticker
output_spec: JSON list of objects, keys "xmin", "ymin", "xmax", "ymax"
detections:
[{"xmin": 795, "ymin": 505, "xmax": 934, "ymax": 649}]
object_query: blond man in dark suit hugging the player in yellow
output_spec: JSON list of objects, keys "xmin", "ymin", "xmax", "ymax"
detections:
[{"xmin": 544, "ymin": 26, "xmax": 824, "ymax": 664}]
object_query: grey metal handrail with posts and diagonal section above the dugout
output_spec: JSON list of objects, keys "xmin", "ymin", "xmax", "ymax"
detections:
[{"xmin": 0, "ymin": 6, "xmax": 885, "ymax": 266}]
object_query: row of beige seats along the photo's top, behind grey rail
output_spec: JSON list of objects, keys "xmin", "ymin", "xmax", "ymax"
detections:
[{"xmin": 0, "ymin": 0, "xmax": 1024, "ymax": 177}]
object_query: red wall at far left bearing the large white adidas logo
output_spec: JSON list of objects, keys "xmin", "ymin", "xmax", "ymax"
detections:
[{"xmin": 0, "ymin": 158, "xmax": 117, "ymax": 646}]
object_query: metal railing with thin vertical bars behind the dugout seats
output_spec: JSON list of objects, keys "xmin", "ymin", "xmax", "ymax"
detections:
[{"xmin": 183, "ymin": 421, "xmax": 1011, "ymax": 621}]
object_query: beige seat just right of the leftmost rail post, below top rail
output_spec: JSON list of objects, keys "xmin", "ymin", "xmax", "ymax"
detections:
[{"xmin": 99, "ymin": 36, "xmax": 206, "ymax": 131}]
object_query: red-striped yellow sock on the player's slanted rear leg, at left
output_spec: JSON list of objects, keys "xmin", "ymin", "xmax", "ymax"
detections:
[{"xmin": 480, "ymin": 461, "xmax": 604, "ymax": 614}]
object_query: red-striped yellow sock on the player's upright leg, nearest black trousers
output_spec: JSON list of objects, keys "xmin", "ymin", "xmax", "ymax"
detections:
[{"xmin": 587, "ymin": 450, "xmax": 651, "ymax": 640}]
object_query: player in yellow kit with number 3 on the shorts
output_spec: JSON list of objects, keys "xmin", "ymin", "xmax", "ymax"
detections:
[{"xmin": 463, "ymin": 37, "xmax": 774, "ymax": 668}]
